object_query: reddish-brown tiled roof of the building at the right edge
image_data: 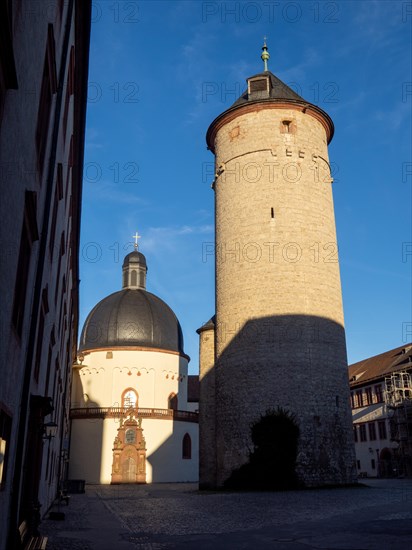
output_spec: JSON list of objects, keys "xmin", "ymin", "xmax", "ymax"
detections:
[{"xmin": 349, "ymin": 343, "xmax": 412, "ymax": 387}]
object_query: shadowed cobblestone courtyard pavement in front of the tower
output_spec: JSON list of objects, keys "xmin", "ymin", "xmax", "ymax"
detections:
[{"xmin": 41, "ymin": 479, "xmax": 412, "ymax": 550}]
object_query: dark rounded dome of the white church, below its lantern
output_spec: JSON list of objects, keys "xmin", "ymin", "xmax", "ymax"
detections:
[{"xmin": 79, "ymin": 288, "xmax": 184, "ymax": 354}]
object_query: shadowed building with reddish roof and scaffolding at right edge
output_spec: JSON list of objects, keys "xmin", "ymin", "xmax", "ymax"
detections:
[{"xmin": 349, "ymin": 344, "xmax": 412, "ymax": 477}]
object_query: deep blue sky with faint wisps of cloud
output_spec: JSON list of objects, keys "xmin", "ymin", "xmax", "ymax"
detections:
[{"xmin": 80, "ymin": 0, "xmax": 412, "ymax": 373}]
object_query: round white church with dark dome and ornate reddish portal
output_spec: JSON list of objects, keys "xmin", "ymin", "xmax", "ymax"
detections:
[{"xmin": 69, "ymin": 246, "xmax": 198, "ymax": 484}]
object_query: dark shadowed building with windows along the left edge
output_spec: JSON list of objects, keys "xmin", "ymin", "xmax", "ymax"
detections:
[{"xmin": 0, "ymin": 0, "xmax": 91, "ymax": 550}]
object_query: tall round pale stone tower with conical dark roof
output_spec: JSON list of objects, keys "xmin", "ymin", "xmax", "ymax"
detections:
[{"xmin": 200, "ymin": 44, "xmax": 355, "ymax": 487}]
